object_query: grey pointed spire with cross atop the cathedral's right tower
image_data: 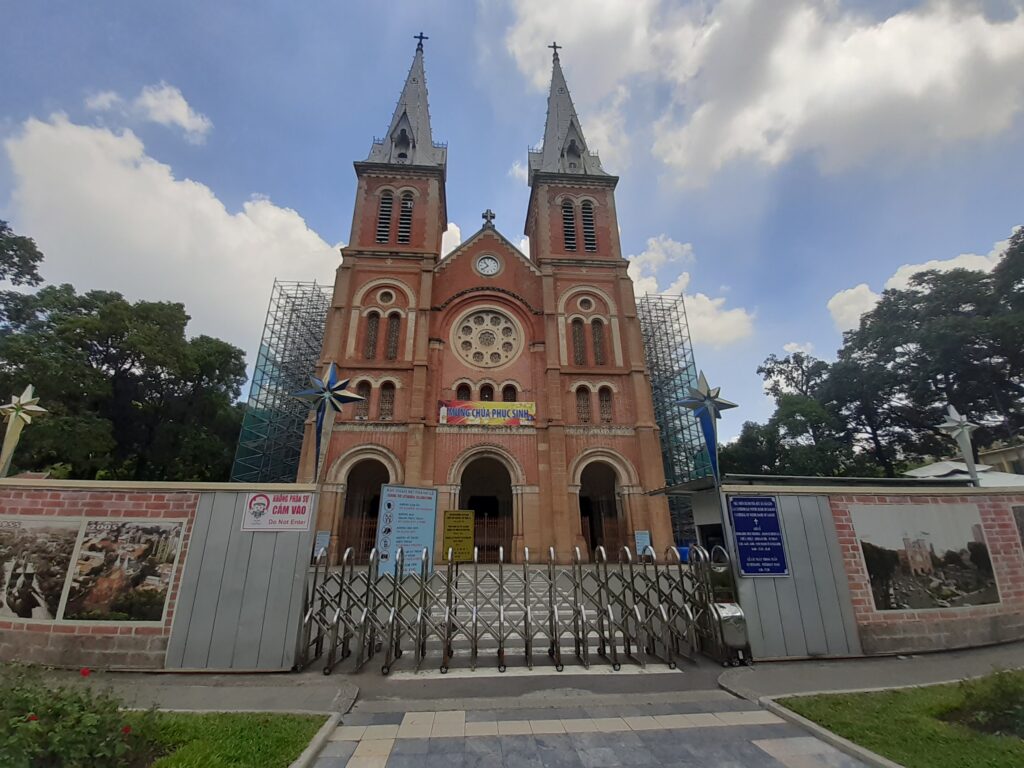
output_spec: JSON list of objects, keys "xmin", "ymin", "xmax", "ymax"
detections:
[{"xmin": 529, "ymin": 43, "xmax": 608, "ymax": 183}]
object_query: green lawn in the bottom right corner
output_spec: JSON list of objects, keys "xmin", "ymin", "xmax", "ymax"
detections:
[{"xmin": 780, "ymin": 673, "xmax": 1024, "ymax": 768}]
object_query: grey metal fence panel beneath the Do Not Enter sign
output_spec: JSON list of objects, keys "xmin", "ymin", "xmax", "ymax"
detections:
[{"xmin": 166, "ymin": 492, "xmax": 312, "ymax": 670}]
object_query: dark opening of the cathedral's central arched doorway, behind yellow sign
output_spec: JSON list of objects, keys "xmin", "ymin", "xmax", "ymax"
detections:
[{"xmin": 459, "ymin": 457, "xmax": 513, "ymax": 562}]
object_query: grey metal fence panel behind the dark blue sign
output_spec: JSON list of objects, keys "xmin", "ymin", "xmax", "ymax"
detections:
[{"xmin": 739, "ymin": 496, "xmax": 860, "ymax": 658}]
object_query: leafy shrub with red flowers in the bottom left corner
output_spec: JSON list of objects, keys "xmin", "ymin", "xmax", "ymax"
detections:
[{"xmin": 0, "ymin": 665, "xmax": 161, "ymax": 768}]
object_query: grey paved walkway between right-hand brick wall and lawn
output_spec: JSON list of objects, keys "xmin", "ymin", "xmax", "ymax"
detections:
[{"xmin": 719, "ymin": 642, "xmax": 1024, "ymax": 701}]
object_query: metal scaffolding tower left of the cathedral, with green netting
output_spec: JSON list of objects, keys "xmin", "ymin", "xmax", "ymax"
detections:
[{"xmin": 231, "ymin": 280, "xmax": 331, "ymax": 482}]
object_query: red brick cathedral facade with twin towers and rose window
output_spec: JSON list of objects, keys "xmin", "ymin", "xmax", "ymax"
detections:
[{"xmin": 299, "ymin": 40, "xmax": 672, "ymax": 562}]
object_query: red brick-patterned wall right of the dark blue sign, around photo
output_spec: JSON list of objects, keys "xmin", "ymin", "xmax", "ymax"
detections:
[{"xmin": 829, "ymin": 494, "xmax": 1024, "ymax": 653}]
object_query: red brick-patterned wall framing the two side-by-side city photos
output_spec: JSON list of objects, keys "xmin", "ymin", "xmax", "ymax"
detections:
[{"xmin": 0, "ymin": 486, "xmax": 199, "ymax": 669}]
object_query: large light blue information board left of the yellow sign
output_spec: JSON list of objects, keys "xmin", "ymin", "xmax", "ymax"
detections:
[{"xmin": 377, "ymin": 485, "xmax": 437, "ymax": 575}]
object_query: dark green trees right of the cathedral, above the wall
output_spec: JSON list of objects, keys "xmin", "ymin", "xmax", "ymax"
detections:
[{"xmin": 721, "ymin": 228, "xmax": 1024, "ymax": 481}]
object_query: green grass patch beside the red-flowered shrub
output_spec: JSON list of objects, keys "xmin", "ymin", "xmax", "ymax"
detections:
[{"xmin": 129, "ymin": 712, "xmax": 327, "ymax": 768}]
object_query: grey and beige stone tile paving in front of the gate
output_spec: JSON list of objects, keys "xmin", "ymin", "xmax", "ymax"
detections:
[{"xmin": 313, "ymin": 702, "xmax": 864, "ymax": 768}]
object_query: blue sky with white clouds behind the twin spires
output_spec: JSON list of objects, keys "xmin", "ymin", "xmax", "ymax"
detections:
[{"xmin": 0, "ymin": 0, "xmax": 1024, "ymax": 437}]
